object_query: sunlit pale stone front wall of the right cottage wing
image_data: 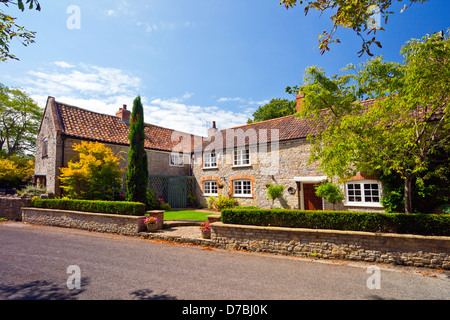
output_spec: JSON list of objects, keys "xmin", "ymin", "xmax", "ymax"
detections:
[{"xmin": 192, "ymin": 139, "xmax": 383, "ymax": 212}]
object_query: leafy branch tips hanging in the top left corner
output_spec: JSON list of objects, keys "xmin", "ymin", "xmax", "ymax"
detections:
[{"xmin": 0, "ymin": 0, "xmax": 41, "ymax": 61}]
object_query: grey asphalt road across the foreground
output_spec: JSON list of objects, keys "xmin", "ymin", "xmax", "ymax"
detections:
[{"xmin": 0, "ymin": 222, "xmax": 450, "ymax": 300}]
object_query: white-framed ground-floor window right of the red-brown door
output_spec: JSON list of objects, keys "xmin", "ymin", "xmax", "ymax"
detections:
[{"xmin": 344, "ymin": 180, "xmax": 383, "ymax": 208}]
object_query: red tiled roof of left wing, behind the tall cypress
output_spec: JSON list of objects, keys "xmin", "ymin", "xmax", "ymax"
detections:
[{"xmin": 48, "ymin": 97, "xmax": 202, "ymax": 151}]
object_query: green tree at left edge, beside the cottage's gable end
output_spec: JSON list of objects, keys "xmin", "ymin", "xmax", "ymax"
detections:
[{"xmin": 0, "ymin": 84, "xmax": 43, "ymax": 155}]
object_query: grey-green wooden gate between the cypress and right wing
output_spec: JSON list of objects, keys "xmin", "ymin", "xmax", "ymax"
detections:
[{"xmin": 148, "ymin": 175, "xmax": 195, "ymax": 208}]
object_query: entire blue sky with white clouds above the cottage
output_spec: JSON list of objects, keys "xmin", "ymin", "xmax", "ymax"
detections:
[{"xmin": 0, "ymin": 0, "xmax": 450, "ymax": 135}]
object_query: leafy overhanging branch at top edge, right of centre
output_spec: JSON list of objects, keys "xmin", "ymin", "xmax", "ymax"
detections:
[{"xmin": 280, "ymin": 0, "xmax": 428, "ymax": 57}]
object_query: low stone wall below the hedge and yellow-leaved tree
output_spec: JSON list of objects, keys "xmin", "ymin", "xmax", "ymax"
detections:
[{"xmin": 22, "ymin": 207, "xmax": 156, "ymax": 236}]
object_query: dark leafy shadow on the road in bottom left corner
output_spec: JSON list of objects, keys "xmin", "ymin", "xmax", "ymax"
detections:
[{"xmin": 0, "ymin": 277, "xmax": 90, "ymax": 300}]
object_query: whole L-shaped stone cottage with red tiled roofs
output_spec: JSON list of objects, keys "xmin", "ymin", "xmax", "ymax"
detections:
[{"xmin": 35, "ymin": 96, "xmax": 382, "ymax": 211}]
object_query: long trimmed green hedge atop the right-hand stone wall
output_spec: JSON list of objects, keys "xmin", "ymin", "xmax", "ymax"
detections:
[{"xmin": 221, "ymin": 209, "xmax": 450, "ymax": 236}]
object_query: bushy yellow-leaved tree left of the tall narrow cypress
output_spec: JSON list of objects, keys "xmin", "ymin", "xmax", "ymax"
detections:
[{"xmin": 59, "ymin": 141, "xmax": 122, "ymax": 200}]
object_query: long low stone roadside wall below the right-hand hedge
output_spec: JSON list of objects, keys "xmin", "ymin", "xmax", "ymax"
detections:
[{"xmin": 212, "ymin": 222, "xmax": 450, "ymax": 270}]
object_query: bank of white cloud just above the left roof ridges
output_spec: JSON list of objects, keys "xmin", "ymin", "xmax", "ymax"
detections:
[{"xmin": 18, "ymin": 62, "xmax": 251, "ymax": 136}]
